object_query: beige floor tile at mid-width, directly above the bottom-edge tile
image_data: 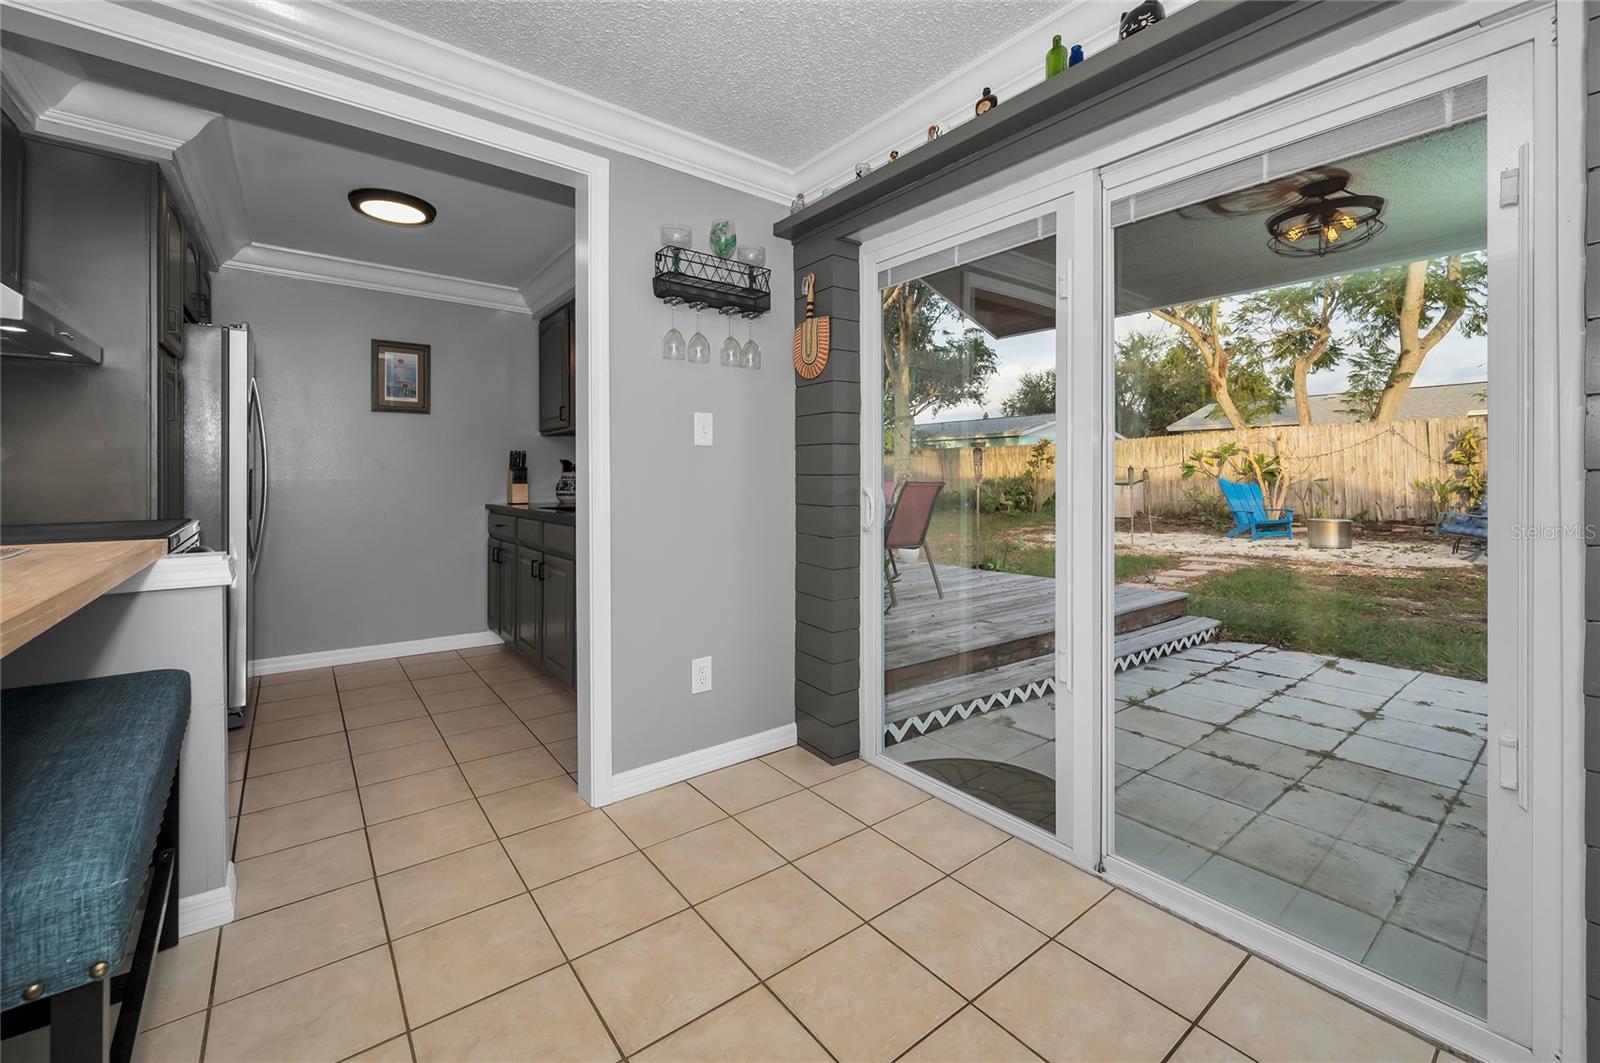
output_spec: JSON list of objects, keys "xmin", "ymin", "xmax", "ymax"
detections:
[{"xmin": 699, "ymin": 866, "xmax": 861, "ymax": 978}]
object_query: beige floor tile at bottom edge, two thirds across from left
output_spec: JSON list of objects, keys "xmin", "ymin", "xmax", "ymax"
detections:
[{"xmin": 976, "ymin": 941, "xmax": 1189, "ymax": 1061}]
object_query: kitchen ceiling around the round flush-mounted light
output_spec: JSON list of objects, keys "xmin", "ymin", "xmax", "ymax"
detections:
[{"xmin": 230, "ymin": 118, "xmax": 574, "ymax": 287}]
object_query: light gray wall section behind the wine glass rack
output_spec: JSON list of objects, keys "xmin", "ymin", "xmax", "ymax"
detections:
[{"xmin": 611, "ymin": 157, "xmax": 795, "ymax": 772}]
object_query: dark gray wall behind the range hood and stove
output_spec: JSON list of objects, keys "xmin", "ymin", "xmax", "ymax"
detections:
[{"xmin": 0, "ymin": 139, "xmax": 155, "ymax": 523}]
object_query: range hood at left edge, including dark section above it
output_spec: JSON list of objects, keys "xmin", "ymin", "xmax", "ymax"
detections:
[{"xmin": 0, "ymin": 108, "xmax": 106, "ymax": 365}]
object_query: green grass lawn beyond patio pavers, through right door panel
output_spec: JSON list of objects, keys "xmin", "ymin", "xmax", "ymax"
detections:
[{"xmin": 1187, "ymin": 565, "xmax": 1488, "ymax": 679}]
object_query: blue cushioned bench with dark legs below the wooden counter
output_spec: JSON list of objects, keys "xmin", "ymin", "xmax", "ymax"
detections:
[{"xmin": 0, "ymin": 669, "xmax": 189, "ymax": 1063}]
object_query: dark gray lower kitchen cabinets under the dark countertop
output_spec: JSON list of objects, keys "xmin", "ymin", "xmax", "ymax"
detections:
[{"xmin": 488, "ymin": 507, "xmax": 578, "ymax": 687}]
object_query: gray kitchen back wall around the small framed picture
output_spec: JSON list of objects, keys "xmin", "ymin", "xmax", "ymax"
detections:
[{"xmin": 213, "ymin": 267, "xmax": 573, "ymax": 658}]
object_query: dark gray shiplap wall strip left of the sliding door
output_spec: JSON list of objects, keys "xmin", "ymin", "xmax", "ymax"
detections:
[{"xmin": 795, "ymin": 237, "xmax": 861, "ymax": 762}]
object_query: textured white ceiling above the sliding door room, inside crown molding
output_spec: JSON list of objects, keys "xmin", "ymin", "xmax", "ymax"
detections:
[{"xmin": 346, "ymin": 0, "xmax": 1062, "ymax": 168}]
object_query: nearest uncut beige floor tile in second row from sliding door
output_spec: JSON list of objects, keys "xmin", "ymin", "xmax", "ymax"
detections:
[{"xmin": 872, "ymin": 879, "xmax": 1048, "ymax": 999}]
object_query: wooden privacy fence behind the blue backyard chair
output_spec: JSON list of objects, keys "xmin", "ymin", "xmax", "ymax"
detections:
[{"xmin": 885, "ymin": 416, "xmax": 1488, "ymax": 520}]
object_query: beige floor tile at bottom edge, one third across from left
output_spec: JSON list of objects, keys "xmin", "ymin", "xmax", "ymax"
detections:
[{"xmin": 411, "ymin": 965, "xmax": 618, "ymax": 1063}]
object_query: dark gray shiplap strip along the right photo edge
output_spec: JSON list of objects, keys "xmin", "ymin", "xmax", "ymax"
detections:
[{"xmin": 1584, "ymin": 3, "xmax": 1600, "ymax": 1060}]
